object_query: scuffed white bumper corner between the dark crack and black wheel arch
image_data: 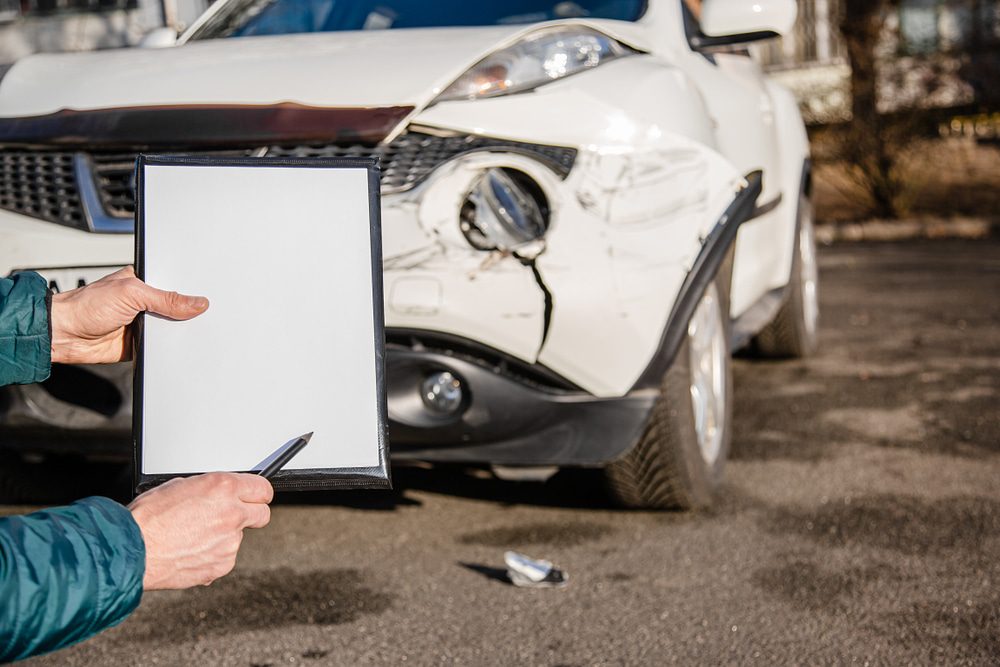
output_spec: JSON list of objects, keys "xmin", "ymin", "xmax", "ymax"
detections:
[{"xmin": 538, "ymin": 145, "xmax": 738, "ymax": 397}]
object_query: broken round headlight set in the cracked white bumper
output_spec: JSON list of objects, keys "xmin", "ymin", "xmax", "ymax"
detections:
[{"xmin": 459, "ymin": 169, "xmax": 549, "ymax": 250}]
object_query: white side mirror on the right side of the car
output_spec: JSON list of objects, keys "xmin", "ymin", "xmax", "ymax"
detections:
[{"xmin": 699, "ymin": 0, "xmax": 798, "ymax": 47}]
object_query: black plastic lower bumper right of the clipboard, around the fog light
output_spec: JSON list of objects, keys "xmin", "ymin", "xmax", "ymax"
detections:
[{"xmin": 387, "ymin": 348, "xmax": 657, "ymax": 466}]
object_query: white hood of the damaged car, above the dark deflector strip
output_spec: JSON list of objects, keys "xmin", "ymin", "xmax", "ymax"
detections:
[{"xmin": 0, "ymin": 22, "xmax": 648, "ymax": 117}]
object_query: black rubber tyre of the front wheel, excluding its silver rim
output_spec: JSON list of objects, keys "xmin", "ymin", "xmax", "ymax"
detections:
[{"xmin": 604, "ymin": 279, "xmax": 733, "ymax": 510}]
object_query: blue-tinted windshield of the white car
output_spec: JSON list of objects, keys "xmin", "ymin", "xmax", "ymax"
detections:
[{"xmin": 192, "ymin": 0, "xmax": 646, "ymax": 39}]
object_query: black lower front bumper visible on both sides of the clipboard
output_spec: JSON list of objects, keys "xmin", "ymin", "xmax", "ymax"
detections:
[{"xmin": 0, "ymin": 331, "xmax": 656, "ymax": 466}]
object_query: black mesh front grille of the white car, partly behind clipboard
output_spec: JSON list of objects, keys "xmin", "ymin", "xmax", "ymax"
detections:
[{"xmin": 0, "ymin": 132, "xmax": 576, "ymax": 228}]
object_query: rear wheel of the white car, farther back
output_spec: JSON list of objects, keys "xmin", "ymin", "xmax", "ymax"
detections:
[{"xmin": 753, "ymin": 195, "xmax": 819, "ymax": 358}]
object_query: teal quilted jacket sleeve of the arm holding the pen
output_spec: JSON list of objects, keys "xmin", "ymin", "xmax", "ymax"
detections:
[{"xmin": 0, "ymin": 498, "xmax": 146, "ymax": 662}]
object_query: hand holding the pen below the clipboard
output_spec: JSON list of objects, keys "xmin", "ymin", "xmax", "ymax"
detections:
[{"xmin": 129, "ymin": 472, "xmax": 274, "ymax": 591}]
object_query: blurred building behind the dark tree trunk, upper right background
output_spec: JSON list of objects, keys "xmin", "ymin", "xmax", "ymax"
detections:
[{"xmin": 755, "ymin": 0, "xmax": 1000, "ymax": 124}]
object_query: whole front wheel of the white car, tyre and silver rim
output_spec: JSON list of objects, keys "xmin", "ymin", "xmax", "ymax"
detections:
[{"xmin": 605, "ymin": 280, "xmax": 733, "ymax": 509}]
